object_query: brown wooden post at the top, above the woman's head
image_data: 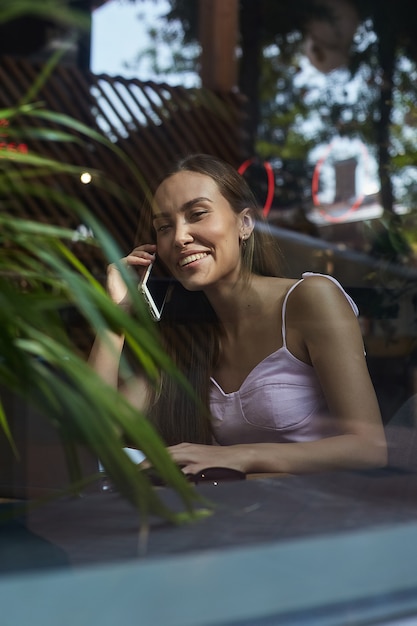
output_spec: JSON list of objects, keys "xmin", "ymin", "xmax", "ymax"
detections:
[{"xmin": 199, "ymin": 0, "xmax": 239, "ymax": 92}]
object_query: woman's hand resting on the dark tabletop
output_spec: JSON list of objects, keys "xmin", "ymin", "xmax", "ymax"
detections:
[{"xmin": 168, "ymin": 443, "xmax": 250, "ymax": 474}]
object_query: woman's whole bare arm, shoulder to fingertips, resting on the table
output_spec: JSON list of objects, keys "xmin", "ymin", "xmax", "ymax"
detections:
[{"xmin": 170, "ymin": 276, "xmax": 387, "ymax": 473}]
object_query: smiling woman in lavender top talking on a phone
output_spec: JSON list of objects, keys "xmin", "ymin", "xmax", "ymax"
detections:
[{"xmin": 91, "ymin": 155, "xmax": 386, "ymax": 473}]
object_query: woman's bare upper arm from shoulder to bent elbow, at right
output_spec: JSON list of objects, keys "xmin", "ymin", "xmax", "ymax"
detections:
[{"xmin": 288, "ymin": 276, "xmax": 387, "ymax": 469}]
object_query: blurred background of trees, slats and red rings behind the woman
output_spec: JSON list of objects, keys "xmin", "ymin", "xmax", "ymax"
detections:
[{"xmin": 0, "ymin": 0, "xmax": 417, "ymax": 422}]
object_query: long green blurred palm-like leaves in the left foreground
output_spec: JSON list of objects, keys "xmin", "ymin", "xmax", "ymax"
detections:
[{"xmin": 0, "ymin": 7, "xmax": 207, "ymax": 522}]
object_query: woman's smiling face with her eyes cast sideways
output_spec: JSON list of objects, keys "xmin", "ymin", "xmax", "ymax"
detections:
[{"xmin": 153, "ymin": 172, "xmax": 251, "ymax": 291}]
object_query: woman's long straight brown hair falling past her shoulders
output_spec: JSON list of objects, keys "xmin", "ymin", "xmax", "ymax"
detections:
[{"xmin": 142, "ymin": 154, "xmax": 281, "ymax": 445}]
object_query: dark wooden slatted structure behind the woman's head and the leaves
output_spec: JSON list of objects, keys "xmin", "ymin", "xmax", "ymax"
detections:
[{"xmin": 0, "ymin": 57, "xmax": 244, "ymax": 270}]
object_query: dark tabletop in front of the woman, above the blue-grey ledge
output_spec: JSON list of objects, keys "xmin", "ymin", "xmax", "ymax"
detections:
[{"xmin": 0, "ymin": 469, "xmax": 417, "ymax": 573}]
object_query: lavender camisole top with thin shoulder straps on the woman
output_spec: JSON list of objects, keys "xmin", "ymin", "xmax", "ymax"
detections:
[{"xmin": 210, "ymin": 272, "xmax": 358, "ymax": 445}]
